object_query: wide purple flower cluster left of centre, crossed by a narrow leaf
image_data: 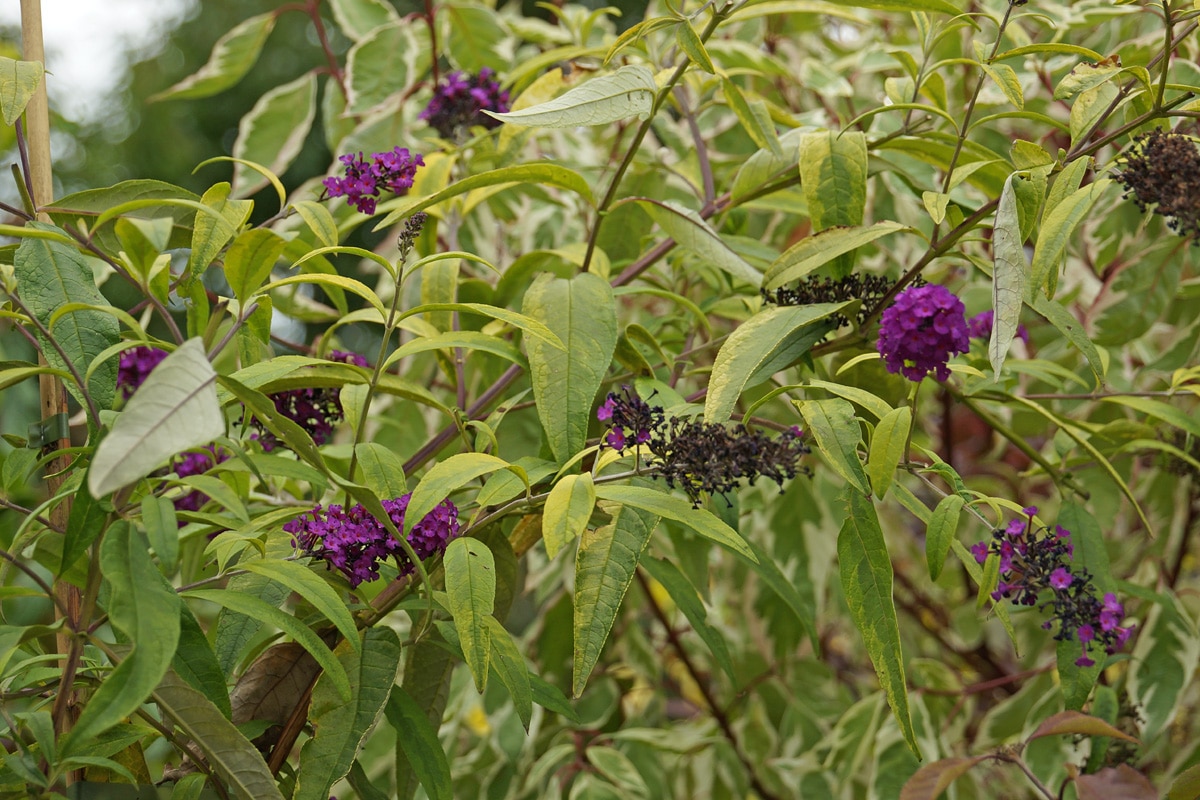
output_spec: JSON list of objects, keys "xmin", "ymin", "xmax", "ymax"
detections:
[{"xmin": 283, "ymin": 493, "xmax": 458, "ymax": 588}]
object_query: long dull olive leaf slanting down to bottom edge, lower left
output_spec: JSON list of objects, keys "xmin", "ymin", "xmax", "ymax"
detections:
[{"xmin": 154, "ymin": 670, "xmax": 283, "ymax": 800}]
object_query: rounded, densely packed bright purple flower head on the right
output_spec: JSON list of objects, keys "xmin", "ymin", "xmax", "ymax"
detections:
[{"xmin": 876, "ymin": 283, "xmax": 970, "ymax": 380}]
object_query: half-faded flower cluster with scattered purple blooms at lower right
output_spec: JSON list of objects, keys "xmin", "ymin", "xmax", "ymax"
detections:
[{"xmin": 971, "ymin": 506, "xmax": 1134, "ymax": 667}]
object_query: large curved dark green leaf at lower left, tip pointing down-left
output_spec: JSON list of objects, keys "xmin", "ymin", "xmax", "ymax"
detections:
[{"xmin": 62, "ymin": 523, "xmax": 180, "ymax": 754}]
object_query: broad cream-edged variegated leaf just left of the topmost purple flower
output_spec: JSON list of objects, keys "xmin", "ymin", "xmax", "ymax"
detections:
[{"xmin": 346, "ymin": 19, "xmax": 431, "ymax": 115}]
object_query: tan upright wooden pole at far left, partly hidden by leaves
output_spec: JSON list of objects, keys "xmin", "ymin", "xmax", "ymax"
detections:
[{"xmin": 20, "ymin": 0, "xmax": 80, "ymax": 753}]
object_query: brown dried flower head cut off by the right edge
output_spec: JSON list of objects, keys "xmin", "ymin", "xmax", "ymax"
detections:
[{"xmin": 1117, "ymin": 130, "xmax": 1200, "ymax": 243}]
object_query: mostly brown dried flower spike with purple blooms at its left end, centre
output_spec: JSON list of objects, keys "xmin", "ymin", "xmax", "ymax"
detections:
[{"xmin": 596, "ymin": 386, "xmax": 809, "ymax": 507}]
